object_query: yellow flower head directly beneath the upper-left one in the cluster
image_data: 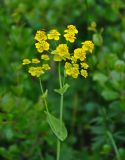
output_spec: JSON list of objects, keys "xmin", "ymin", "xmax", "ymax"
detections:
[{"xmin": 35, "ymin": 41, "xmax": 49, "ymax": 53}]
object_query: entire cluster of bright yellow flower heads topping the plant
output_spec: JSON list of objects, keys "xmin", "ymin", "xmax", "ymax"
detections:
[{"xmin": 22, "ymin": 25, "xmax": 94, "ymax": 78}]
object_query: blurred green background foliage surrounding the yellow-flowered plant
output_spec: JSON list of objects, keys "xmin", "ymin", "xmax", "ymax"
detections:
[{"xmin": 0, "ymin": 0, "xmax": 125, "ymax": 160}]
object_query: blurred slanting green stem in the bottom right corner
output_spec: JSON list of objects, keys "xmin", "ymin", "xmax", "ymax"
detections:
[{"xmin": 107, "ymin": 131, "xmax": 121, "ymax": 160}]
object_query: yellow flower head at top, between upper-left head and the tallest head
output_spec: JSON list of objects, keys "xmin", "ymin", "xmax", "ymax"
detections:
[{"xmin": 47, "ymin": 29, "xmax": 60, "ymax": 41}]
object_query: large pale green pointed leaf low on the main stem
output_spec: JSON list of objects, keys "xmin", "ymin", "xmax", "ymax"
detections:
[{"xmin": 45, "ymin": 112, "xmax": 67, "ymax": 141}]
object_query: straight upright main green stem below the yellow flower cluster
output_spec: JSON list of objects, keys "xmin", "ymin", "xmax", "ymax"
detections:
[{"xmin": 56, "ymin": 63, "xmax": 63, "ymax": 160}]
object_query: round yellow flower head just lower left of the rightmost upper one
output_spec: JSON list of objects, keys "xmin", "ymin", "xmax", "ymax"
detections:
[{"xmin": 74, "ymin": 48, "xmax": 86, "ymax": 61}]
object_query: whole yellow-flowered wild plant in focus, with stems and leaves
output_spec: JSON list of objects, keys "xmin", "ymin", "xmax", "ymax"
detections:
[{"xmin": 22, "ymin": 25, "xmax": 94, "ymax": 160}]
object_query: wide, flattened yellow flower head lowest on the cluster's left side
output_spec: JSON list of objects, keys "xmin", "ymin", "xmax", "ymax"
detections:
[{"xmin": 28, "ymin": 67, "xmax": 44, "ymax": 77}]
